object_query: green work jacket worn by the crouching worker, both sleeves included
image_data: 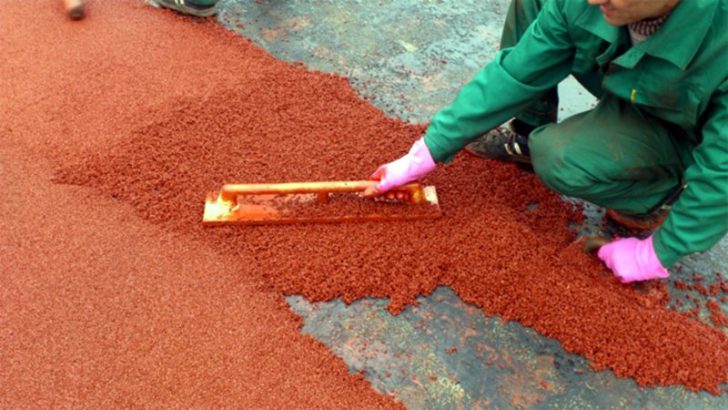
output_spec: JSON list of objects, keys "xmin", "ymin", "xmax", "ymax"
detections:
[{"xmin": 425, "ymin": 0, "xmax": 728, "ymax": 267}]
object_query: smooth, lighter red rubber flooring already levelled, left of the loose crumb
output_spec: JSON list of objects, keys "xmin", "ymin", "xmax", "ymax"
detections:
[{"xmin": 0, "ymin": 0, "xmax": 395, "ymax": 409}]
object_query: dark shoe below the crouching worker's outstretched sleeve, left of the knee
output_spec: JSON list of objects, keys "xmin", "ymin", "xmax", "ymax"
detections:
[{"xmin": 465, "ymin": 121, "xmax": 531, "ymax": 164}]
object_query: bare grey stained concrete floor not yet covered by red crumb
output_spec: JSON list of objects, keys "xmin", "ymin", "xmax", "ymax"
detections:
[{"xmin": 213, "ymin": 0, "xmax": 728, "ymax": 409}]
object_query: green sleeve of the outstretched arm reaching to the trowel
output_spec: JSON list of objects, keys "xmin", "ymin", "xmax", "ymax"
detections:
[{"xmin": 425, "ymin": 0, "xmax": 574, "ymax": 162}]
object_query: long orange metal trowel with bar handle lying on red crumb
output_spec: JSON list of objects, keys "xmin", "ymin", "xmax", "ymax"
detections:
[{"xmin": 202, "ymin": 181, "xmax": 441, "ymax": 225}]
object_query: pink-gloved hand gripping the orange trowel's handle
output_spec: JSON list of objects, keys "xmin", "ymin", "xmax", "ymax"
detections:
[{"xmin": 364, "ymin": 138, "xmax": 436, "ymax": 196}]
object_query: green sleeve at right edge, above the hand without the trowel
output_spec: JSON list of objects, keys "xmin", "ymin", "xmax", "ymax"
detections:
[{"xmin": 653, "ymin": 81, "xmax": 728, "ymax": 267}]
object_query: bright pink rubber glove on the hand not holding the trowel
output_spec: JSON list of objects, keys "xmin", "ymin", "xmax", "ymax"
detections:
[{"xmin": 597, "ymin": 236, "xmax": 670, "ymax": 283}]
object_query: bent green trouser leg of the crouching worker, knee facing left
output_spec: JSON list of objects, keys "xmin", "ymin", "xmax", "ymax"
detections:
[{"xmin": 528, "ymin": 95, "xmax": 693, "ymax": 215}]
